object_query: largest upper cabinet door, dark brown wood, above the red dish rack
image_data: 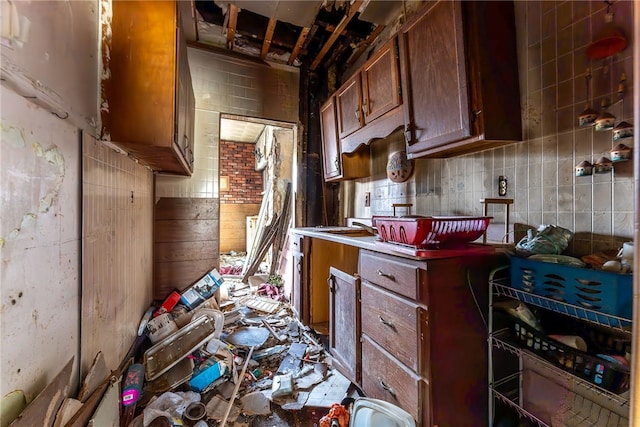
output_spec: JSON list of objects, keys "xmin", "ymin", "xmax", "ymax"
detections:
[{"xmin": 400, "ymin": 1, "xmax": 470, "ymax": 154}]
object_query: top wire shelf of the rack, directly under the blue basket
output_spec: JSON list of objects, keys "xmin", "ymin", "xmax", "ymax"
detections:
[{"xmin": 493, "ymin": 279, "xmax": 631, "ymax": 334}]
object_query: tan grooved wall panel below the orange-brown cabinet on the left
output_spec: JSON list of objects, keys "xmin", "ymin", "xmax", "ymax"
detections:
[{"xmin": 80, "ymin": 134, "xmax": 154, "ymax": 373}]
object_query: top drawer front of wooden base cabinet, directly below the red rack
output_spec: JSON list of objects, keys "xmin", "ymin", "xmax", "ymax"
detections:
[{"xmin": 358, "ymin": 251, "xmax": 426, "ymax": 302}]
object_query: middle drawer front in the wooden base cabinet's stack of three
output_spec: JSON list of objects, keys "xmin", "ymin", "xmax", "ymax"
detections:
[{"xmin": 360, "ymin": 282, "xmax": 421, "ymax": 372}]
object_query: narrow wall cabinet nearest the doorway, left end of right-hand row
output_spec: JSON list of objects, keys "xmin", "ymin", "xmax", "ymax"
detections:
[{"xmin": 320, "ymin": 96, "xmax": 371, "ymax": 181}]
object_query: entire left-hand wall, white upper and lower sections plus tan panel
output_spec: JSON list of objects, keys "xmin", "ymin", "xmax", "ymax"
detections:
[{"xmin": 0, "ymin": 0, "xmax": 154, "ymax": 402}]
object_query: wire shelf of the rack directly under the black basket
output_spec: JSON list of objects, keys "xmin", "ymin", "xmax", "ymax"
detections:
[{"xmin": 491, "ymin": 336, "xmax": 629, "ymax": 410}]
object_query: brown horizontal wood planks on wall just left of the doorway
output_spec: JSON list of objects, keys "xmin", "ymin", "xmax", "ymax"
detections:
[{"xmin": 153, "ymin": 197, "xmax": 220, "ymax": 300}]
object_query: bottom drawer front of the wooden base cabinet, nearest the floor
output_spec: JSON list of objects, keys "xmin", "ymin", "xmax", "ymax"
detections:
[{"xmin": 362, "ymin": 335, "xmax": 428, "ymax": 425}]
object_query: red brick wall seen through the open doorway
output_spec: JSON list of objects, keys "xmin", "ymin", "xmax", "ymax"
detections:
[{"xmin": 220, "ymin": 141, "xmax": 262, "ymax": 204}]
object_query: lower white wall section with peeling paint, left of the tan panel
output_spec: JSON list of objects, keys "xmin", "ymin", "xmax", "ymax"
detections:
[{"xmin": 0, "ymin": 88, "xmax": 81, "ymax": 398}]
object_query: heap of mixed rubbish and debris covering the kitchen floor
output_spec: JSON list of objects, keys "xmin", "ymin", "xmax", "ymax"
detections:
[{"xmin": 121, "ymin": 270, "xmax": 354, "ymax": 427}]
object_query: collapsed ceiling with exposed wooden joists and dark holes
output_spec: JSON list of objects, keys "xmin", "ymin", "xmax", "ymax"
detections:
[{"xmin": 183, "ymin": 0, "xmax": 408, "ymax": 70}]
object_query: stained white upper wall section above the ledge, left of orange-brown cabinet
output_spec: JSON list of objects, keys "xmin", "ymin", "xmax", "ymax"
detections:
[{"xmin": 0, "ymin": 0, "xmax": 101, "ymax": 135}]
